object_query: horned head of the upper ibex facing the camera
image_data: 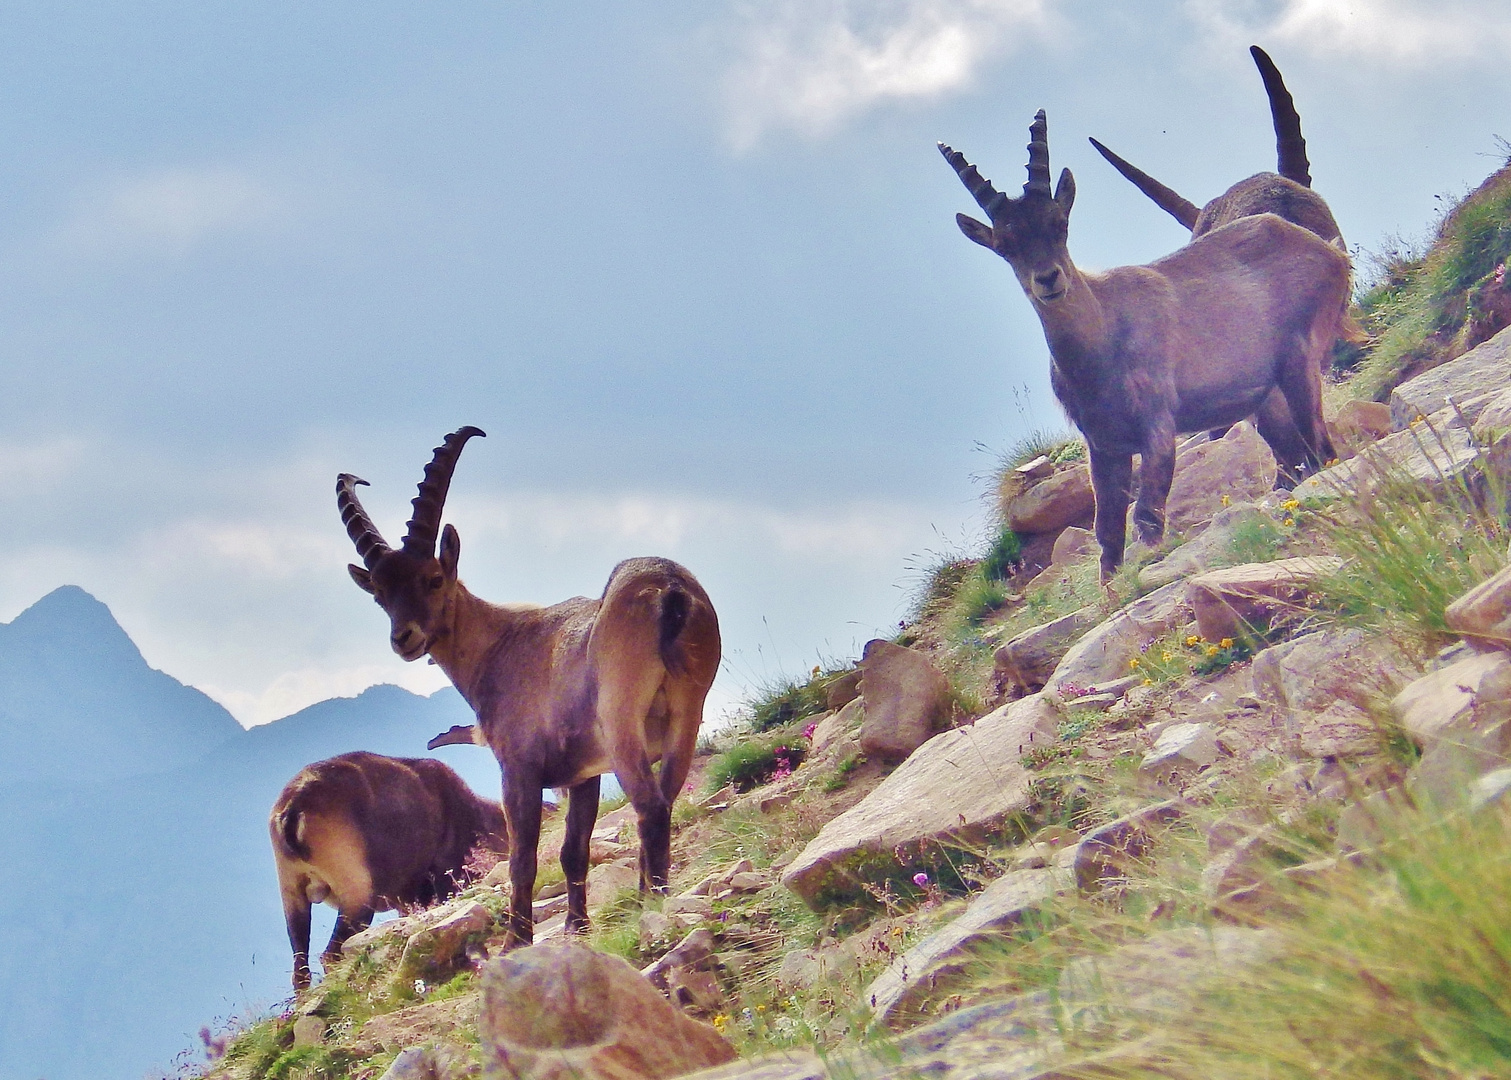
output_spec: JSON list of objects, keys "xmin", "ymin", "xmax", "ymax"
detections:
[{"xmin": 940, "ymin": 109, "xmax": 1076, "ymax": 304}]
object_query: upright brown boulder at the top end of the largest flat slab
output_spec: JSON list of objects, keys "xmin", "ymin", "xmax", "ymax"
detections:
[{"xmin": 858, "ymin": 637, "xmax": 949, "ymax": 764}]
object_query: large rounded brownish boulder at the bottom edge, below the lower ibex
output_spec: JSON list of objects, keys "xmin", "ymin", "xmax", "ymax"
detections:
[{"xmin": 477, "ymin": 944, "xmax": 734, "ymax": 1080}]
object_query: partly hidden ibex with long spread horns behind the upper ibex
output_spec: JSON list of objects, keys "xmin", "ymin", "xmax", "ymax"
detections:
[{"xmin": 1091, "ymin": 45, "xmax": 1345, "ymax": 248}]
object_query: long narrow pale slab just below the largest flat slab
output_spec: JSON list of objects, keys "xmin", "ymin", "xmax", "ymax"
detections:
[{"xmin": 866, "ymin": 869, "xmax": 1076, "ymax": 1023}]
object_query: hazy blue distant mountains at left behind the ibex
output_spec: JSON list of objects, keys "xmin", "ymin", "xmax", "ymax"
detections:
[{"xmin": 0, "ymin": 586, "xmax": 499, "ymax": 1080}]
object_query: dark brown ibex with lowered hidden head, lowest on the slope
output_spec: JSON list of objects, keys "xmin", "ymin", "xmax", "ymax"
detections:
[{"xmin": 267, "ymin": 751, "xmax": 509, "ymax": 989}]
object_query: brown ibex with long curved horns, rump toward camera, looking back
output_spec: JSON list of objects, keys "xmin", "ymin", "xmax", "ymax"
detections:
[{"xmin": 335, "ymin": 427, "xmax": 719, "ymax": 944}]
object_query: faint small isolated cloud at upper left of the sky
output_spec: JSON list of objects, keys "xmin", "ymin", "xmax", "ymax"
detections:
[{"xmin": 54, "ymin": 165, "xmax": 290, "ymax": 258}]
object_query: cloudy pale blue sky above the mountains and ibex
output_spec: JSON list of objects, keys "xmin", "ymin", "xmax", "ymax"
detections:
[{"xmin": 0, "ymin": 0, "xmax": 1511, "ymax": 724}]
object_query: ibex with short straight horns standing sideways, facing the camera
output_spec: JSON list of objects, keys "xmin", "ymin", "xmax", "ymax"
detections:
[{"xmin": 940, "ymin": 109, "xmax": 1349, "ymax": 580}]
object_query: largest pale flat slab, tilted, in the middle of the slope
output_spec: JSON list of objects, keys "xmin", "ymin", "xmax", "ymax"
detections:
[{"xmin": 781, "ymin": 695, "xmax": 1059, "ymax": 908}]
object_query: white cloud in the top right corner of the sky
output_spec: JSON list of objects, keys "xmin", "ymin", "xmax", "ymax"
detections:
[{"xmin": 1188, "ymin": 0, "xmax": 1511, "ymax": 65}]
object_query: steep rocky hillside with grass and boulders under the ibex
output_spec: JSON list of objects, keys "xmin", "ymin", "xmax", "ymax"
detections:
[{"xmin": 184, "ymin": 174, "xmax": 1511, "ymax": 1080}]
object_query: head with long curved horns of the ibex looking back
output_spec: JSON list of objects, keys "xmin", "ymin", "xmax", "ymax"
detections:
[{"xmin": 335, "ymin": 427, "xmax": 482, "ymax": 660}]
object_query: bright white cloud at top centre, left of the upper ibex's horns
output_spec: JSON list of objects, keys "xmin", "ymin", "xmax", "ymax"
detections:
[{"xmin": 725, "ymin": 0, "xmax": 1050, "ymax": 150}]
